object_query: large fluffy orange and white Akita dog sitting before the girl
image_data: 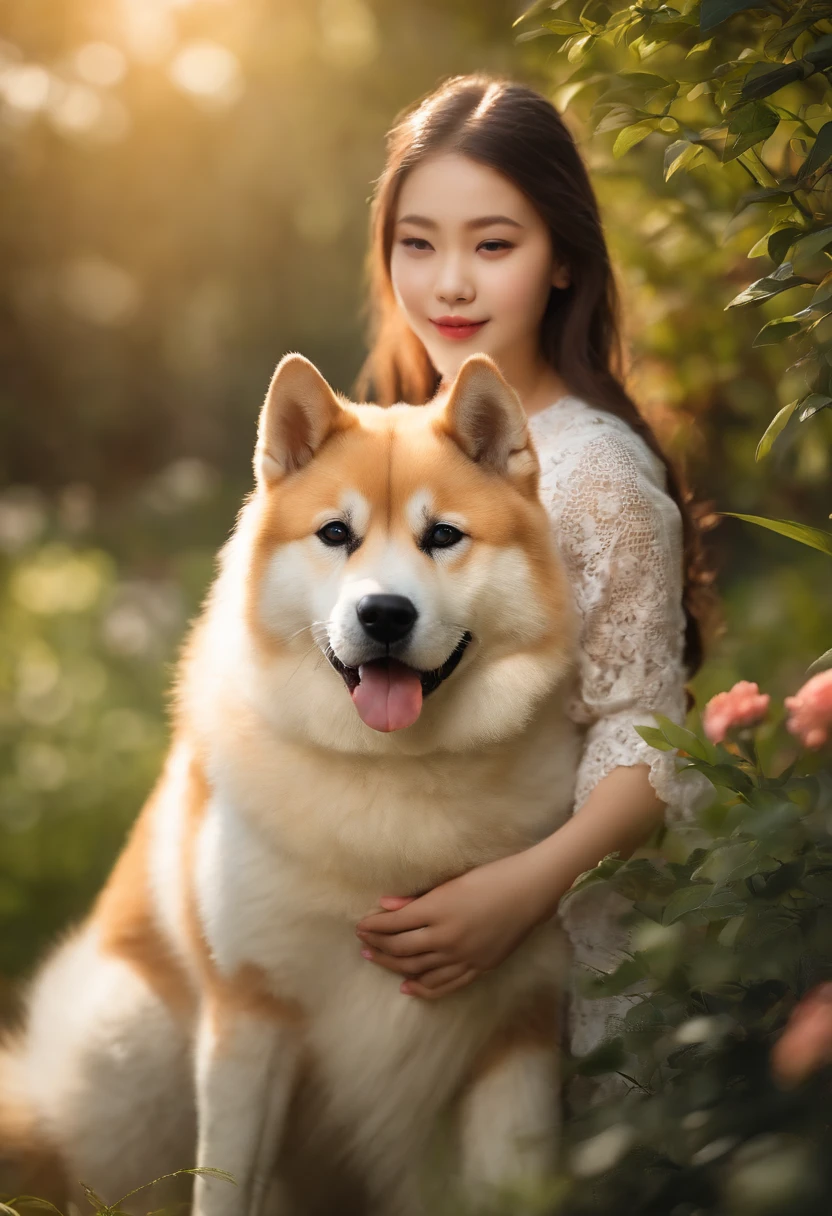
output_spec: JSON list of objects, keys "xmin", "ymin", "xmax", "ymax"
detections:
[{"xmin": 0, "ymin": 355, "xmax": 579, "ymax": 1216}]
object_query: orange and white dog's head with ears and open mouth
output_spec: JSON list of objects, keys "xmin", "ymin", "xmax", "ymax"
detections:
[{"xmin": 240, "ymin": 355, "xmax": 574, "ymax": 750}]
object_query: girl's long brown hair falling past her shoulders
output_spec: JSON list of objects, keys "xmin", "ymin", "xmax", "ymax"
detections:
[{"xmin": 355, "ymin": 74, "xmax": 713, "ymax": 685}]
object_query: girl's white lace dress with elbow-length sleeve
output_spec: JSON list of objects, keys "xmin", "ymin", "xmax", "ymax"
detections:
[{"xmin": 529, "ymin": 395, "xmax": 710, "ymax": 1079}]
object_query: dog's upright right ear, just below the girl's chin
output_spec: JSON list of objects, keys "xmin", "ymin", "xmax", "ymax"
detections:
[{"xmin": 442, "ymin": 355, "xmax": 536, "ymax": 475}]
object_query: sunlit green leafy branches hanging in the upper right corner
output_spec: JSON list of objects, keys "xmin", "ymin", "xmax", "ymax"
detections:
[{"xmin": 523, "ymin": 0, "xmax": 832, "ymax": 460}]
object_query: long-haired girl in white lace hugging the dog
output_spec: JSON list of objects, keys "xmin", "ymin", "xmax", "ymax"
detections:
[{"xmin": 356, "ymin": 75, "xmax": 709, "ymax": 1089}]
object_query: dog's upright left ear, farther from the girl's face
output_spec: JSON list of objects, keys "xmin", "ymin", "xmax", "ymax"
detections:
[{"xmin": 254, "ymin": 355, "xmax": 352, "ymax": 484}]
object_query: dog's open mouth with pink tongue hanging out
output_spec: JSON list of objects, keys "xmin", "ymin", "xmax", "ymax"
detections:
[{"xmin": 326, "ymin": 632, "xmax": 471, "ymax": 731}]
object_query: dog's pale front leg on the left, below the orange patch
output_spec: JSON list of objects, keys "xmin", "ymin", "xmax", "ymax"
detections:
[{"xmin": 193, "ymin": 1006, "xmax": 299, "ymax": 1216}]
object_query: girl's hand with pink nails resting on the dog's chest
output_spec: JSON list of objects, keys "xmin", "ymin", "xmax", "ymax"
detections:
[{"xmin": 355, "ymin": 851, "xmax": 553, "ymax": 1001}]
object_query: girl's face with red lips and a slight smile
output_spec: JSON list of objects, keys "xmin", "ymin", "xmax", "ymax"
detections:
[{"xmin": 390, "ymin": 152, "xmax": 569, "ymax": 381}]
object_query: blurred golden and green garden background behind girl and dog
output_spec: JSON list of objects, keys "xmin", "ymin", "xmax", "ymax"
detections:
[{"xmin": 0, "ymin": 0, "xmax": 832, "ymax": 1012}]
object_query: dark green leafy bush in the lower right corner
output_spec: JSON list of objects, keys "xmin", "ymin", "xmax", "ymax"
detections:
[{"xmin": 566, "ymin": 720, "xmax": 832, "ymax": 1216}]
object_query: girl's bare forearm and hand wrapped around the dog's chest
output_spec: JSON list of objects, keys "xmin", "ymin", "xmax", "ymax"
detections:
[{"xmin": 356, "ymin": 764, "xmax": 665, "ymax": 1000}]
